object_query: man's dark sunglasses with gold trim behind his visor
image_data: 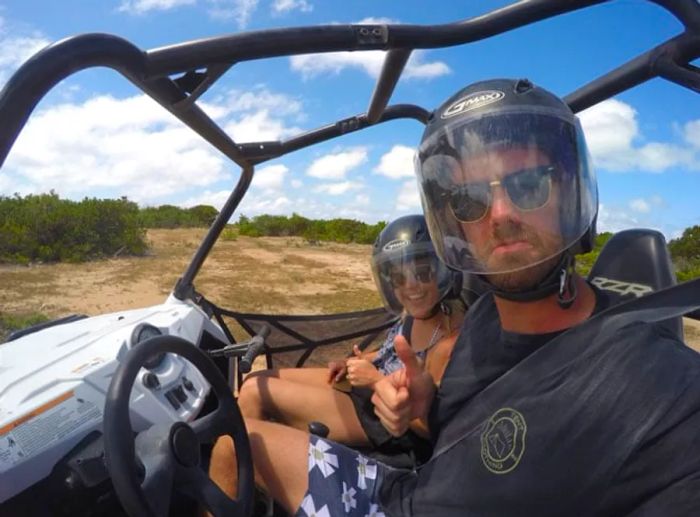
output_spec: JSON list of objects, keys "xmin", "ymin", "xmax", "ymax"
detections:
[{"xmin": 448, "ymin": 165, "xmax": 555, "ymax": 223}]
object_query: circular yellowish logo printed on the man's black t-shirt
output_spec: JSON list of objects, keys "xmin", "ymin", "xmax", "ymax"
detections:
[{"xmin": 481, "ymin": 408, "xmax": 527, "ymax": 474}]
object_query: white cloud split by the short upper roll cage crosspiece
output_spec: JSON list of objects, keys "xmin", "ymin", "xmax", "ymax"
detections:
[{"xmin": 290, "ymin": 50, "xmax": 451, "ymax": 79}]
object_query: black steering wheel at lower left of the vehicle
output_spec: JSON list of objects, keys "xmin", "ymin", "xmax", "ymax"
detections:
[{"xmin": 104, "ymin": 336, "xmax": 254, "ymax": 517}]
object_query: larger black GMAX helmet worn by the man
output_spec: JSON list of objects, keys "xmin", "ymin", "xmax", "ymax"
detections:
[{"xmin": 416, "ymin": 79, "xmax": 598, "ymax": 275}]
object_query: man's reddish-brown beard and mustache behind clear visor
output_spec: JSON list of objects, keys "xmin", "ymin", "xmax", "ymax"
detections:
[{"xmin": 484, "ymin": 217, "xmax": 561, "ymax": 292}]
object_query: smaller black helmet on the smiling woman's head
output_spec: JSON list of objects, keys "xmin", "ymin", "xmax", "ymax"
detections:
[{"xmin": 371, "ymin": 215, "xmax": 462, "ymax": 314}]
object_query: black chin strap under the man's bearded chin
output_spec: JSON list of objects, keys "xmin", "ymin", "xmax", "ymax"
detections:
[{"xmin": 481, "ymin": 251, "xmax": 578, "ymax": 309}]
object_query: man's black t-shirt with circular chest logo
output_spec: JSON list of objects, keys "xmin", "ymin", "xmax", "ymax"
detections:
[{"xmin": 380, "ymin": 292, "xmax": 700, "ymax": 516}]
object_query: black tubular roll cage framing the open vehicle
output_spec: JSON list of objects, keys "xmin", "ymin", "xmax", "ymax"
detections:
[{"xmin": 0, "ymin": 0, "xmax": 700, "ymax": 301}]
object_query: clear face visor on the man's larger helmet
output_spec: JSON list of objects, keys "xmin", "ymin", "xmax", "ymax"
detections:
[{"xmin": 416, "ymin": 110, "xmax": 598, "ymax": 275}]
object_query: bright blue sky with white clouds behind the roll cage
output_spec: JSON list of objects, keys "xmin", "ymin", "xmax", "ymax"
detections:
[{"xmin": 0, "ymin": 0, "xmax": 700, "ymax": 238}]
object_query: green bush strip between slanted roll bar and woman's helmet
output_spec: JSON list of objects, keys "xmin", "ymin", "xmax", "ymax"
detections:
[{"xmin": 238, "ymin": 214, "xmax": 386, "ymax": 244}]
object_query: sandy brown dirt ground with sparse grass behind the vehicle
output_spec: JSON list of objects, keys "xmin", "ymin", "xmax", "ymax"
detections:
[{"xmin": 0, "ymin": 229, "xmax": 700, "ymax": 351}]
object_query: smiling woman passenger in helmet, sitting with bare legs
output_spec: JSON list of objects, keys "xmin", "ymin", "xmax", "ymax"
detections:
[{"xmin": 232, "ymin": 215, "xmax": 465, "ymax": 465}]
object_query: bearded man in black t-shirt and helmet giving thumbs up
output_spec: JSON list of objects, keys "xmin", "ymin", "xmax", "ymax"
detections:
[{"xmin": 209, "ymin": 80, "xmax": 700, "ymax": 516}]
